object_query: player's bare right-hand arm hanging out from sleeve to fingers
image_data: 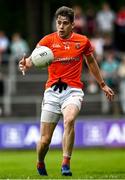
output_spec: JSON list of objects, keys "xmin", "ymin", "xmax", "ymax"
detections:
[{"xmin": 86, "ymin": 54, "xmax": 114, "ymax": 101}]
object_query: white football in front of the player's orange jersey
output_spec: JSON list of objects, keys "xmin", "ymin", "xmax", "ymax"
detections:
[{"xmin": 31, "ymin": 46, "xmax": 54, "ymax": 68}]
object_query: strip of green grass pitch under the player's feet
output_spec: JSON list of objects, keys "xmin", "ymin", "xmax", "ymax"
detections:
[{"xmin": 0, "ymin": 149, "xmax": 125, "ymax": 179}]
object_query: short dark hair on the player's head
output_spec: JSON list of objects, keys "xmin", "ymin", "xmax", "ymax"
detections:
[{"xmin": 55, "ymin": 6, "xmax": 74, "ymax": 23}]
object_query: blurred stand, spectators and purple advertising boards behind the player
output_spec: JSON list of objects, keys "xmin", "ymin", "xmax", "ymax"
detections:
[{"xmin": 0, "ymin": 0, "xmax": 125, "ymax": 149}]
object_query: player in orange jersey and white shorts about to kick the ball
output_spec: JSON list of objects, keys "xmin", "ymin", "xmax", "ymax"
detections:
[{"xmin": 19, "ymin": 6, "xmax": 114, "ymax": 176}]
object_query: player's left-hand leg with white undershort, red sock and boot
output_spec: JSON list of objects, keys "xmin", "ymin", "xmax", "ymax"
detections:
[{"xmin": 37, "ymin": 110, "xmax": 60, "ymax": 175}]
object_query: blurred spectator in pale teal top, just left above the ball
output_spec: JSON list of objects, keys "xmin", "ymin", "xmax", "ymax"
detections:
[{"xmin": 10, "ymin": 33, "xmax": 30, "ymax": 61}]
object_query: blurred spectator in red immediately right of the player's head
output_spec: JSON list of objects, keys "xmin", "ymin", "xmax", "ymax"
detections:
[{"xmin": 73, "ymin": 5, "xmax": 86, "ymax": 34}]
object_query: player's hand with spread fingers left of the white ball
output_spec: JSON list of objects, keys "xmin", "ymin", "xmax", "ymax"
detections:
[{"xmin": 19, "ymin": 56, "xmax": 33, "ymax": 75}]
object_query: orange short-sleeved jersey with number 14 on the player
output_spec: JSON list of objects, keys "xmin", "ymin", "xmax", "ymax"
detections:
[{"xmin": 38, "ymin": 32, "xmax": 93, "ymax": 88}]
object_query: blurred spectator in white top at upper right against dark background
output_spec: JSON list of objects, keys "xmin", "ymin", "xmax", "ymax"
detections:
[{"xmin": 96, "ymin": 2, "xmax": 115, "ymax": 35}]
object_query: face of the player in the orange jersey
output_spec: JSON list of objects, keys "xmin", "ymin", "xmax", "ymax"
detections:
[{"xmin": 56, "ymin": 15, "xmax": 74, "ymax": 39}]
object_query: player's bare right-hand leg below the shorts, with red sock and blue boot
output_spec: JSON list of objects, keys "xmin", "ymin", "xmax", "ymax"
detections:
[{"xmin": 62, "ymin": 104, "xmax": 79, "ymax": 176}]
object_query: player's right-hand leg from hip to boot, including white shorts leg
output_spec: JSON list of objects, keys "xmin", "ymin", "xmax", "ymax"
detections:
[{"xmin": 61, "ymin": 88, "xmax": 84, "ymax": 176}]
